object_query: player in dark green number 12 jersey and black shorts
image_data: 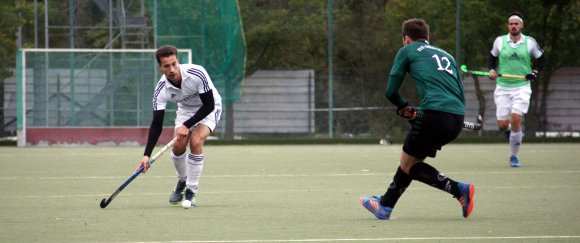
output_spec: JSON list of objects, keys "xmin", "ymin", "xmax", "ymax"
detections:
[{"xmin": 360, "ymin": 19, "xmax": 475, "ymax": 220}]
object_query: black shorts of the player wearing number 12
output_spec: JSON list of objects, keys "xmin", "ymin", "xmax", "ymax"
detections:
[{"xmin": 403, "ymin": 110, "xmax": 464, "ymax": 159}]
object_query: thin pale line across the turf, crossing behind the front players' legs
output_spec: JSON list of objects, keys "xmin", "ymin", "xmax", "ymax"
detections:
[{"xmin": 0, "ymin": 170, "xmax": 580, "ymax": 180}]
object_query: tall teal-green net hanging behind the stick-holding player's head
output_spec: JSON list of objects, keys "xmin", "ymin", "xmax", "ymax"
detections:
[{"xmin": 148, "ymin": 0, "xmax": 246, "ymax": 104}]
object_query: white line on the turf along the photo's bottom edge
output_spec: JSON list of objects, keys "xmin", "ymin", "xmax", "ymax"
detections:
[{"xmin": 121, "ymin": 235, "xmax": 580, "ymax": 243}]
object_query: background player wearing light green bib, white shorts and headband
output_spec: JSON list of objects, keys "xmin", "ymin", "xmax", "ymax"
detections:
[{"xmin": 488, "ymin": 12, "xmax": 546, "ymax": 168}]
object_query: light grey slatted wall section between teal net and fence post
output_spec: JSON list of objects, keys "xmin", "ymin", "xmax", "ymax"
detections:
[{"xmin": 234, "ymin": 70, "xmax": 315, "ymax": 134}]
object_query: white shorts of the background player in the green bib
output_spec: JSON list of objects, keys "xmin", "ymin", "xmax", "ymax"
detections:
[{"xmin": 494, "ymin": 84, "xmax": 532, "ymax": 120}]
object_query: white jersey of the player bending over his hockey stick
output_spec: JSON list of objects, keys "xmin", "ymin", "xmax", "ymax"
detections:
[{"xmin": 153, "ymin": 64, "xmax": 222, "ymax": 115}]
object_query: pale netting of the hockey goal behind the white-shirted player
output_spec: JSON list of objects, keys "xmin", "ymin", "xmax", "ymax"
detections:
[{"xmin": 17, "ymin": 49, "xmax": 191, "ymax": 128}]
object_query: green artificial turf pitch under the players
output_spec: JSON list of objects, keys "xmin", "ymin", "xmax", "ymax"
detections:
[{"xmin": 0, "ymin": 143, "xmax": 580, "ymax": 242}]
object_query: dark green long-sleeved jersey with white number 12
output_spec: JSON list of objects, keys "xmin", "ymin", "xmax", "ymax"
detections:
[{"xmin": 385, "ymin": 41, "xmax": 465, "ymax": 115}]
